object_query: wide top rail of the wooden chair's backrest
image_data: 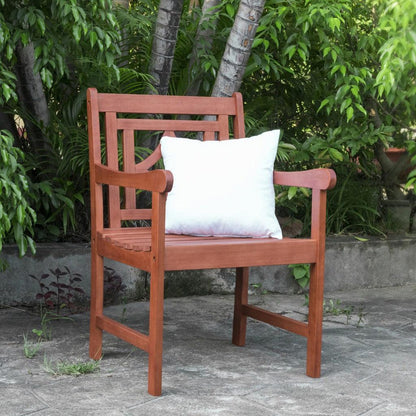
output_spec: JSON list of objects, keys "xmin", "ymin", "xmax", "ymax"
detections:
[{"xmin": 98, "ymin": 93, "xmax": 236, "ymax": 115}]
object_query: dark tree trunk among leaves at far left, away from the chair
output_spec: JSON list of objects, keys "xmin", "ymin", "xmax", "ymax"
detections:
[{"xmin": 16, "ymin": 42, "xmax": 50, "ymax": 154}]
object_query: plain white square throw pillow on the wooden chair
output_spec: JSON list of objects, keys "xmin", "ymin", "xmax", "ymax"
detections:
[{"xmin": 160, "ymin": 130, "xmax": 282, "ymax": 238}]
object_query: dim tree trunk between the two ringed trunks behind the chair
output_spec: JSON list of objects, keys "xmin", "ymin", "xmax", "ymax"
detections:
[{"xmin": 186, "ymin": 0, "xmax": 220, "ymax": 95}]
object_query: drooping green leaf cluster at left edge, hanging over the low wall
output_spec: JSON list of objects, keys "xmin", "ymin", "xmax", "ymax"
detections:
[{"xmin": 0, "ymin": 130, "xmax": 36, "ymax": 267}]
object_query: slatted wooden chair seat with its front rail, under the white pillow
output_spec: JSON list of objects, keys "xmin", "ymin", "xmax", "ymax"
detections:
[{"xmin": 97, "ymin": 227, "xmax": 317, "ymax": 270}]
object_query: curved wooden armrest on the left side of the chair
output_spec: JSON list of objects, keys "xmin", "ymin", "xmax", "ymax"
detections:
[{"xmin": 94, "ymin": 165, "xmax": 173, "ymax": 193}]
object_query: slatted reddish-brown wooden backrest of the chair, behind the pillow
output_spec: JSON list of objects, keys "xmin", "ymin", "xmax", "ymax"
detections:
[{"xmin": 87, "ymin": 88, "xmax": 245, "ymax": 228}]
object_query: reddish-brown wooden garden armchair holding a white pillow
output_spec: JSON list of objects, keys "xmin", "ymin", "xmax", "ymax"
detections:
[{"xmin": 87, "ymin": 88, "xmax": 336, "ymax": 395}]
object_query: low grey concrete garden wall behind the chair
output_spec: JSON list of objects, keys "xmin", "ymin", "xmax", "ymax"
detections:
[{"xmin": 0, "ymin": 235, "xmax": 416, "ymax": 305}]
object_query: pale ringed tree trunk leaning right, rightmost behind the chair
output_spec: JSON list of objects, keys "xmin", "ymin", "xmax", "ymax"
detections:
[{"xmin": 211, "ymin": 0, "xmax": 265, "ymax": 97}]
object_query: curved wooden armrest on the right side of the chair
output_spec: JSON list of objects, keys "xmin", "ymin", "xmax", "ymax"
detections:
[{"xmin": 273, "ymin": 169, "xmax": 337, "ymax": 190}]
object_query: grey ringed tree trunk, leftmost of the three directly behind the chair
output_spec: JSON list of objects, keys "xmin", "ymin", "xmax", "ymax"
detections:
[{"xmin": 149, "ymin": 0, "xmax": 183, "ymax": 95}]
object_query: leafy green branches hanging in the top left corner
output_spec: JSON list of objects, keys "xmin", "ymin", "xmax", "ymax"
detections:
[{"xmin": 0, "ymin": 0, "xmax": 119, "ymax": 104}]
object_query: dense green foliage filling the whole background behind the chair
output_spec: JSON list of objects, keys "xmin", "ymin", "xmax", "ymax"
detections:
[{"xmin": 0, "ymin": 0, "xmax": 416, "ymax": 249}]
